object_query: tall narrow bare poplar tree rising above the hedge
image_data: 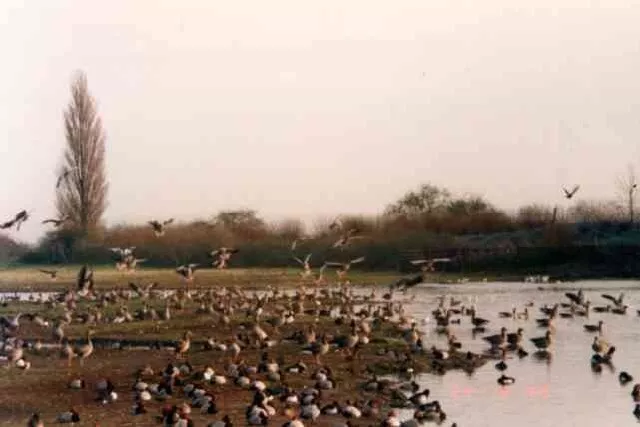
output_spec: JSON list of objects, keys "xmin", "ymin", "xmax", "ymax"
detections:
[{"xmin": 56, "ymin": 72, "xmax": 108, "ymax": 236}]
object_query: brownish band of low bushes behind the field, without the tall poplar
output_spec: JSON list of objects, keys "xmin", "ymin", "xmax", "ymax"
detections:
[{"xmin": 6, "ymin": 185, "xmax": 640, "ymax": 279}]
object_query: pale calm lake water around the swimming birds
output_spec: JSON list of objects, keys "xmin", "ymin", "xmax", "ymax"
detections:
[{"xmin": 390, "ymin": 281, "xmax": 640, "ymax": 427}]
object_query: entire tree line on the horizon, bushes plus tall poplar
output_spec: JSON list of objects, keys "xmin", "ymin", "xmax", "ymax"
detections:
[{"xmin": 1, "ymin": 73, "xmax": 637, "ymax": 276}]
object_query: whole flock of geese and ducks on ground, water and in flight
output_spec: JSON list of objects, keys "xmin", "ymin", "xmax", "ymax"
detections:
[{"xmin": 5, "ymin": 182, "xmax": 640, "ymax": 427}]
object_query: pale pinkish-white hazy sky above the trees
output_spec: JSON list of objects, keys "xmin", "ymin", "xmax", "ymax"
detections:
[{"xmin": 0, "ymin": 0, "xmax": 640, "ymax": 242}]
